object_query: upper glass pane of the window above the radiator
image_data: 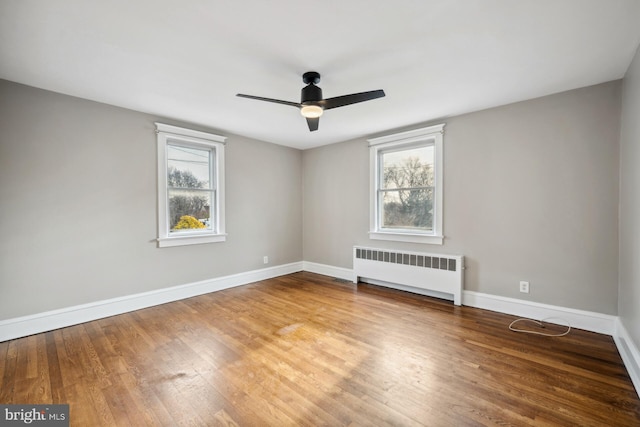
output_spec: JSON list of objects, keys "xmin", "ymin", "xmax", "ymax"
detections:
[{"xmin": 380, "ymin": 144, "xmax": 434, "ymax": 189}]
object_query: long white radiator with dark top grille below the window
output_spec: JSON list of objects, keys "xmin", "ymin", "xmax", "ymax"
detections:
[{"xmin": 353, "ymin": 246, "xmax": 464, "ymax": 305}]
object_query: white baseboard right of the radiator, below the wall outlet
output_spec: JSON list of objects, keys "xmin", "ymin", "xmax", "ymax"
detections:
[{"xmin": 462, "ymin": 291, "xmax": 617, "ymax": 335}]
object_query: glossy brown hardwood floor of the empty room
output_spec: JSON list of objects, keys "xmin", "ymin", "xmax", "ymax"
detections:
[{"xmin": 0, "ymin": 273, "xmax": 640, "ymax": 426}]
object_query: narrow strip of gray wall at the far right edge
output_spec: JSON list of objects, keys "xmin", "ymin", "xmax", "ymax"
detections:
[{"xmin": 618, "ymin": 46, "xmax": 640, "ymax": 347}]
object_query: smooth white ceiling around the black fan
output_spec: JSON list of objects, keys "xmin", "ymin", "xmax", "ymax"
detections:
[{"xmin": 0, "ymin": 0, "xmax": 640, "ymax": 149}]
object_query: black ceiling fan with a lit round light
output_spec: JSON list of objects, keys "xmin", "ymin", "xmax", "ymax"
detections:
[{"xmin": 236, "ymin": 71, "xmax": 384, "ymax": 132}]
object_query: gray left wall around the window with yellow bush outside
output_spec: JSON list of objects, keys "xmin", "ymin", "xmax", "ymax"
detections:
[{"xmin": 0, "ymin": 80, "xmax": 302, "ymax": 320}]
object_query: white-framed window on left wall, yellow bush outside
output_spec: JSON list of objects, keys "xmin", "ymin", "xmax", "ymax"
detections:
[{"xmin": 156, "ymin": 123, "xmax": 226, "ymax": 247}]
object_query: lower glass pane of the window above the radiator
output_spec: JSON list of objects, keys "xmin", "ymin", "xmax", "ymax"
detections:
[{"xmin": 381, "ymin": 187, "xmax": 433, "ymax": 231}]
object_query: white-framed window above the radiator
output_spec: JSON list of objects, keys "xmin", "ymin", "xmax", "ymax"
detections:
[{"xmin": 369, "ymin": 124, "xmax": 444, "ymax": 245}]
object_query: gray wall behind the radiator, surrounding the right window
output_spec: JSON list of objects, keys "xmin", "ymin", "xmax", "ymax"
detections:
[{"xmin": 303, "ymin": 81, "xmax": 621, "ymax": 314}]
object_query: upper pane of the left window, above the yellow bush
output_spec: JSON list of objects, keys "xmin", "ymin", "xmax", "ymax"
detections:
[{"xmin": 167, "ymin": 145, "xmax": 212, "ymax": 188}]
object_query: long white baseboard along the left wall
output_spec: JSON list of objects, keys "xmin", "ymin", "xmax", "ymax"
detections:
[{"xmin": 0, "ymin": 262, "xmax": 303, "ymax": 342}]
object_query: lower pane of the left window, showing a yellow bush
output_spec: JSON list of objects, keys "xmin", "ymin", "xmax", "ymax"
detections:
[{"xmin": 169, "ymin": 190, "xmax": 214, "ymax": 232}]
